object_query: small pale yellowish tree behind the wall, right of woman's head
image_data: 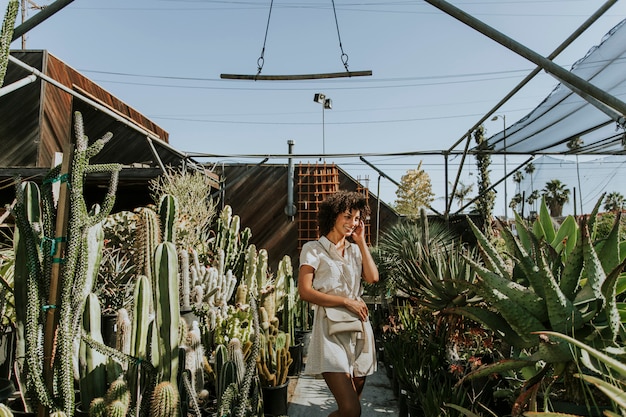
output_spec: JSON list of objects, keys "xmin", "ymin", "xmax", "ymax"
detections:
[{"xmin": 396, "ymin": 161, "xmax": 434, "ymax": 217}]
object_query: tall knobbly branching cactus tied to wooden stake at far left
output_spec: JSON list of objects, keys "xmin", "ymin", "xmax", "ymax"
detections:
[{"xmin": 14, "ymin": 112, "xmax": 121, "ymax": 415}]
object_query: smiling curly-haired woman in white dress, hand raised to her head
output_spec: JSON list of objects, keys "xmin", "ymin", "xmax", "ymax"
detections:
[{"xmin": 298, "ymin": 191, "xmax": 378, "ymax": 417}]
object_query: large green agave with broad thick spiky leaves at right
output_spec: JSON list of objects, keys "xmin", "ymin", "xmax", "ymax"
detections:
[{"xmin": 446, "ymin": 195, "xmax": 625, "ymax": 410}]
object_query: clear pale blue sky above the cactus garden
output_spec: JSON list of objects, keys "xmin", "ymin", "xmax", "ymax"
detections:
[{"xmin": 0, "ymin": 0, "xmax": 626, "ymax": 216}]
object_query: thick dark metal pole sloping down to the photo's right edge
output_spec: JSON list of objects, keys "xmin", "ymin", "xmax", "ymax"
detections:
[{"xmin": 425, "ymin": 0, "xmax": 626, "ymax": 126}]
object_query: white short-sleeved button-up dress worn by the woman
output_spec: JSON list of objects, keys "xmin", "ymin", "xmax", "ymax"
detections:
[{"xmin": 300, "ymin": 236, "xmax": 377, "ymax": 377}]
